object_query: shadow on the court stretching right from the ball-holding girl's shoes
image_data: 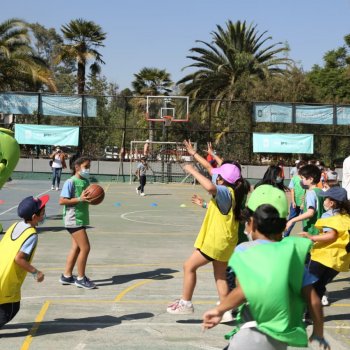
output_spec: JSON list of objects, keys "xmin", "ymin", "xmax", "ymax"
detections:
[{"xmin": 94, "ymin": 268, "xmax": 179, "ymax": 287}]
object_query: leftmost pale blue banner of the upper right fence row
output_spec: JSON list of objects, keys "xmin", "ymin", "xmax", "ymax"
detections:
[{"xmin": 254, "ymin": 103, "xmax": 292, "ymax": 123}]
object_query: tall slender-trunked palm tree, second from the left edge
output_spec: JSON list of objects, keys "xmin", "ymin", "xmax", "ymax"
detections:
[{"xmin": 56, "ymin": 18, "xmax": 106, "ymax": 94}]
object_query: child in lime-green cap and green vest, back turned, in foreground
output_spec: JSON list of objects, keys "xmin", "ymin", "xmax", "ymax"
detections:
[{"xmin": 203, "ymin": 185, "xmax": 330, "ymax": 350}]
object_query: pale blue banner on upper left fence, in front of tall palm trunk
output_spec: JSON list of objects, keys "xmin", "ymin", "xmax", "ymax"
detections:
[{"xmin": 41, "ymin": 95, "xmax": 97, "ymax": 117}]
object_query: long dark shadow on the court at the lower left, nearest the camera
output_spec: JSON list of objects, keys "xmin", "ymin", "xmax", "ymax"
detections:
[{"xmin": 0, "ymin": 312, "xmax": 154, "ymax": 338}]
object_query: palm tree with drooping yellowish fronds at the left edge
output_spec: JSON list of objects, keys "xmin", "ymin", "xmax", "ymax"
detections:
[{"xmin": 0, "ymin": 18, "xmax": 56, "ymax": 91}]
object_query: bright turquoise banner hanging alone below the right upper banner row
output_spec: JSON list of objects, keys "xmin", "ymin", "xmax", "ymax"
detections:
[{"xmin": 253, "ymin": 133, "xmax": 314, "ymax": 154}]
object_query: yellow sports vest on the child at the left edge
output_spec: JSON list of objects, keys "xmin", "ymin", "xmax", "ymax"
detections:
[{"xmin": 0, "ymin": 222, "xmax": 36, "ymax": 304}]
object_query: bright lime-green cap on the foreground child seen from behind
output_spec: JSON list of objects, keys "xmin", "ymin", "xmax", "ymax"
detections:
[{"xmin": 247, "ymin": 185, "xmax": 288, "ymax": 219}]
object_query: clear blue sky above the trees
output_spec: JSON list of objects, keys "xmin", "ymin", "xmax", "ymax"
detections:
[{"xmin": 0, "ymin": 0, "xmax": 350, "ymax": 89}]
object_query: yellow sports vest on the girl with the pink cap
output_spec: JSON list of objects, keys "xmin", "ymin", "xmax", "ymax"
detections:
[{"xmin": 194, "ymin": 187, "xmax": 239, "ymax": 261}]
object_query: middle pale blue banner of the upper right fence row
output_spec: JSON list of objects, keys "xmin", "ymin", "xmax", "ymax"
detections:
[{"xmin": 295, "ymin": 105, "xmax": 333, "ymax": 125}]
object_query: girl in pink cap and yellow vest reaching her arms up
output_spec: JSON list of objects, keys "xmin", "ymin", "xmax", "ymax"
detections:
[{"xmin": 167, "ymin": 142, "xmax": 245, "ymax": 314}]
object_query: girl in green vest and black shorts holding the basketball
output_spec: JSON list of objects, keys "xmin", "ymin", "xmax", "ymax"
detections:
[{"xmin": 59, "ymin": 157, "xmax": 96, "ymax": 289}]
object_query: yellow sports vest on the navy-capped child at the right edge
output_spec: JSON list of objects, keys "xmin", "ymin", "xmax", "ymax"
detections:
[{"xmin": 311, "ymin": 214, "xmax": 350, "ymax": 272}]
